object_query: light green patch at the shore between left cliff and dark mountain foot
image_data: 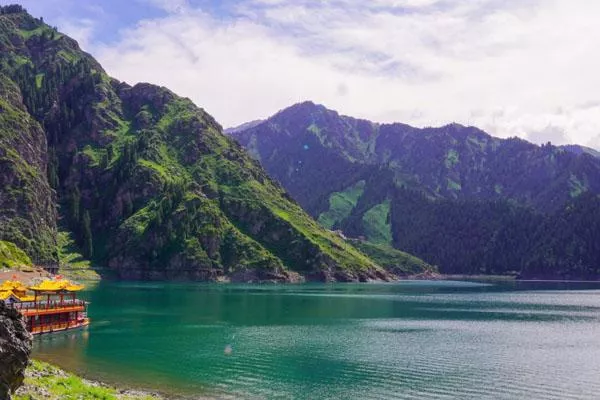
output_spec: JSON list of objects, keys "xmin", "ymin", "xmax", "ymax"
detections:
[{"xmin": 58, "ymin": 231, "xmax": 100, "ymax": 280}]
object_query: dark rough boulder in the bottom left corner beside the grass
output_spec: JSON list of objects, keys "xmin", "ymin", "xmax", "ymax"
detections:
[{"xmin": 0, "ymin": 301, "xmax": 31, "ymax": 399}]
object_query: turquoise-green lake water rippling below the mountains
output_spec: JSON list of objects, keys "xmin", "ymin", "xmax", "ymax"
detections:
[{"xmin": 35, "ymin": 281, "xmax": 600, "ymax": 399}]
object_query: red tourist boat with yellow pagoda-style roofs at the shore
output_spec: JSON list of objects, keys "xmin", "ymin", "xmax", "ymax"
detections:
[{"xmin": 0, "ymin": 276, "xmax": 90, "ymax": 335}]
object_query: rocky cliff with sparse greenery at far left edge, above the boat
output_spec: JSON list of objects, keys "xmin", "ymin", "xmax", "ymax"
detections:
[{"xmin": 0, "ymin": 65, "xmax": 57, "ymax": 264}]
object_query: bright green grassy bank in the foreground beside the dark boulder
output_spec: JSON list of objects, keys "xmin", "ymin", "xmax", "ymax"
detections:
[{"xmin": 13, "ymin": 360, "xmax": 157, "ymax": 400}]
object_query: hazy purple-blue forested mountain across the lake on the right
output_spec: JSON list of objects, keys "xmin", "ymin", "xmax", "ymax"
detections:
[{"xmin": 231, "ymin": 102, "xmax": 600, "ymax": 278}]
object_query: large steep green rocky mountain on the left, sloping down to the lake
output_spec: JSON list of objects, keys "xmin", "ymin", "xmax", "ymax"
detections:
[{"xmin": 0, "ymin": 6, "xmax": 404, "ymax": 281}]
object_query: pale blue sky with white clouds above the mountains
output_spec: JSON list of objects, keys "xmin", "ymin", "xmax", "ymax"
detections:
[{"xmin": 0, "ymin": 0, "xmax": 600, "ymax": 149}]
